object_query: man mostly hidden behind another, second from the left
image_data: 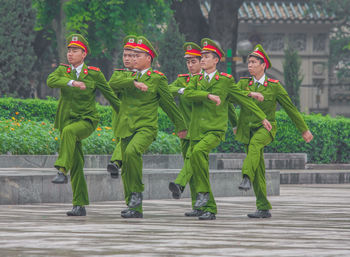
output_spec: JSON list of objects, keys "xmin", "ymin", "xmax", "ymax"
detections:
[{"xmin": 107, "ymin": 35, "xmax": 136, "ymax": 178}]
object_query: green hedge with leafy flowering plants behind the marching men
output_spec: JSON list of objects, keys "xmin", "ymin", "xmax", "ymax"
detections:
[{"xmin": 0, "ymin": 98, "xmax": 350, "ymax": 163}]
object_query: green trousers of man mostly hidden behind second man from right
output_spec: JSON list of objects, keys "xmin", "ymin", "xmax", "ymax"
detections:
[{"xmin": 174, "ymin": 139, "xmax": 196, "ymax": 208}]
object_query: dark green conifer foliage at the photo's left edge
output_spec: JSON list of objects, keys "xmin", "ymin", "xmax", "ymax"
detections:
[{"xmin": 0, "ymin": 0, "xmax": 35, "ymax": 97}]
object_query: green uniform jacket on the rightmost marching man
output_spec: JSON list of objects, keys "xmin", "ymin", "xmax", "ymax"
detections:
[{"xmin": 236, "ymin": 76, "xmax": 308, "ymax": 144}]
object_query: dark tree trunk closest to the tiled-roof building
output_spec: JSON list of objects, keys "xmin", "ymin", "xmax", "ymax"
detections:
[{"xmin": 209, "ymin": 0, "xmax": 244, "ymax": 76}]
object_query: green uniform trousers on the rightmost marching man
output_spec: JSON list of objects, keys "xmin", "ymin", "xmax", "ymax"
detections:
[{"xmin": 242, "ymin": 127, "xmax": 272, "ymax": 210}]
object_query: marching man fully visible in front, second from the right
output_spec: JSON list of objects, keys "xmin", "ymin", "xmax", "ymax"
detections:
[{"xmin": 184, "ymin": 38, "xmax": 271, "ymax": 220}]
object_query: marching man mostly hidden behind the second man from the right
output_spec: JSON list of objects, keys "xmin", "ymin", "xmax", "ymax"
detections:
[{"xmin": 169, "ymin": 42, "xmax": 202, "ymax": 199}]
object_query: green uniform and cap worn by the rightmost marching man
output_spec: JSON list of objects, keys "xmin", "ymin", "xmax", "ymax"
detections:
[{"xmin": 236, "ymin": 45, "xmax": 308, "ymax": 210}]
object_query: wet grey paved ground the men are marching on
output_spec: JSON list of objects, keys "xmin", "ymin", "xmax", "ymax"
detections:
[{"xmin": 0, "ymin": 184, "xmax": 350, "ymax": 257}]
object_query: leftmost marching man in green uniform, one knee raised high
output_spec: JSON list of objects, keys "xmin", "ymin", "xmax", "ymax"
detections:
[{"xmin": 47, "ymin": 34, "xmax": 120, "ymax": 216}]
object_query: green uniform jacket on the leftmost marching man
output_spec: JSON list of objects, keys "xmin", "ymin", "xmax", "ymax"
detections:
[{"xmin": 47, "ymin": 64, "xmax": 120, "ymax": 131}]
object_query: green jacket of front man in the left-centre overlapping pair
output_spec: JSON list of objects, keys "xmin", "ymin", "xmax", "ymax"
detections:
[{"xmin": 109, "ymin": 69, "xmax": 187, "ymax": 138}]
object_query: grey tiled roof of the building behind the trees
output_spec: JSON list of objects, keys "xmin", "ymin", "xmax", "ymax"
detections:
[{"xmin": 238, "ymin": 0, "xmax": 335, "ymax": 23}]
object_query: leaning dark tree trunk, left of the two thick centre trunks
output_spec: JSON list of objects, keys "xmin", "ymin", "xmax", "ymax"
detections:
[{"xmin": 171, "ymin": 0, "xmax": 209, "ymax": 44}]
